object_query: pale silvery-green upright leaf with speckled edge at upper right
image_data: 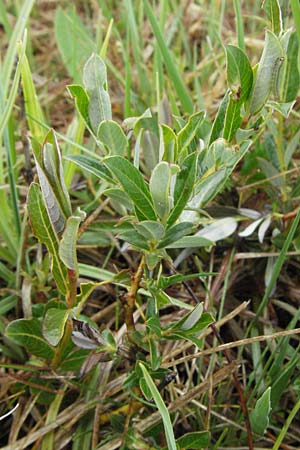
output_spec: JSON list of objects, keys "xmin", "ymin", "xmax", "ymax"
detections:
[{"xmin": 249, "ymin": 30, "xmax": 284, "ymax": 115}]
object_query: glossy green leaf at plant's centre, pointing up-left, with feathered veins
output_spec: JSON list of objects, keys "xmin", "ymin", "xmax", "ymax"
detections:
[{"xmin": 104, "ymin": 156, "xmax": 156, "ymax": 220}]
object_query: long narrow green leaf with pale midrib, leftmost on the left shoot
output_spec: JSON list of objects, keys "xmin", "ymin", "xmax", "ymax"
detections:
[{"xmin": 27, "ymin": 183, "xmax": 68, "ymax": 294}]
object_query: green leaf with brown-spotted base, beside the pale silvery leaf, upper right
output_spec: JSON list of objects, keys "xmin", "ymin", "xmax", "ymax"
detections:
[{"xmin": 225, "ymin": 45, "xmax": 253, "ymax": 102}]
